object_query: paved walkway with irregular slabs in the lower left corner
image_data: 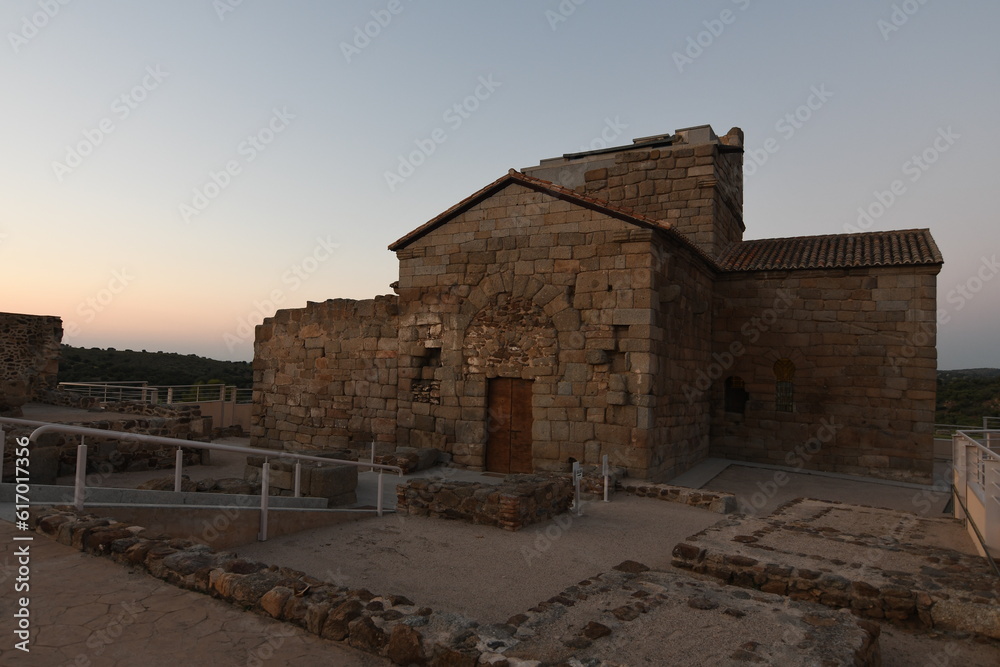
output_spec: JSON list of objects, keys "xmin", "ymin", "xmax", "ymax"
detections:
[{"xmin": 0, "ymin": 521, "xmax": 389, "ymax": 667}]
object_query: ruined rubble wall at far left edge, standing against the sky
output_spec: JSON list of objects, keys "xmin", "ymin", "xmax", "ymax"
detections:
[{"xmin": 0, "ymin": 313, "xmax": 62, "ymax": 415}]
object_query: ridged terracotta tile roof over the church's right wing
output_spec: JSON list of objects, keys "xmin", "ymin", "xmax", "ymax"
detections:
[{"xmin": 718, "ymin": 229, "xmax": 944, "ymax": 271}]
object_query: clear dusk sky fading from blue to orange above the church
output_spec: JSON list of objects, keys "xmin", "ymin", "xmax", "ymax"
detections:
[{"xmin": 0, "ymin": 0, "xmax": 1000, "ymax": 369}]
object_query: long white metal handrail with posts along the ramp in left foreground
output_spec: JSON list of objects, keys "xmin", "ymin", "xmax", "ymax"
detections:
[{"xmin": 0, "ymin": 417, "xmax": 403, "ymax": 542}]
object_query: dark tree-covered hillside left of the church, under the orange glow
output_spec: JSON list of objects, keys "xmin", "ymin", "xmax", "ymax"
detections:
[{"xmin": 59, "ymin": 345, "xmax": 253, "ymax": 388}]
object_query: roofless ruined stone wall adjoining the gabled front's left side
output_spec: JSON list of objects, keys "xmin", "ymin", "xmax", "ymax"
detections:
[{"xmin": 250, "ymin": 296, "xmax": 398, "ymax": 450}]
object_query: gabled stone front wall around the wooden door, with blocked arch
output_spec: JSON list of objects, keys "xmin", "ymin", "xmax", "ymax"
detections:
[{"xmin": 397, "ymin": 185, "xmax": 680, "ymax": 477}]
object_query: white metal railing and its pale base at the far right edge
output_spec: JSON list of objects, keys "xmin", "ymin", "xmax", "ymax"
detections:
[{"xmin": 952, "ymin": 429, "xmax": 1000, "ymax": 568}]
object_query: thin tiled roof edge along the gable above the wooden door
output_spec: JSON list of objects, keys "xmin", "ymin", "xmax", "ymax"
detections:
[{"xmin": 389, "ymin": 169, "xmax": 693, "ymax": 251}]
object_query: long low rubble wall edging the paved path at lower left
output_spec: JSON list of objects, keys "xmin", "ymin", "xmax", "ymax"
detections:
[{"xmin": 34, "ymin": 509, "xmax": 496, "ymax": 667}]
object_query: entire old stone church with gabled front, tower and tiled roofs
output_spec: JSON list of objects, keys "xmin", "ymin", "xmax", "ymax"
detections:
[{"xmin": 252, "ymin": 126, "xmax": 942, "ymax": 481}]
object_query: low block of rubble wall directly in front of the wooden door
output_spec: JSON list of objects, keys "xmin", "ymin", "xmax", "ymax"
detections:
[{"xmin": 396, "ymin": 474, "xmax": 573, "ymax": 530}]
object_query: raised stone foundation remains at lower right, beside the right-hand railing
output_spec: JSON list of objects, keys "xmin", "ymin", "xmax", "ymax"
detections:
[{"xmin": 673, "ymin": 499, "xmax": 1000, "ymax": 639}]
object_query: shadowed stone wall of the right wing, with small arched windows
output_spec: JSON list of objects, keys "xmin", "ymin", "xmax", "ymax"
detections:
[{"xmin": 712, "ymin": 267, "xmax": 939, "ymax": 481}]
